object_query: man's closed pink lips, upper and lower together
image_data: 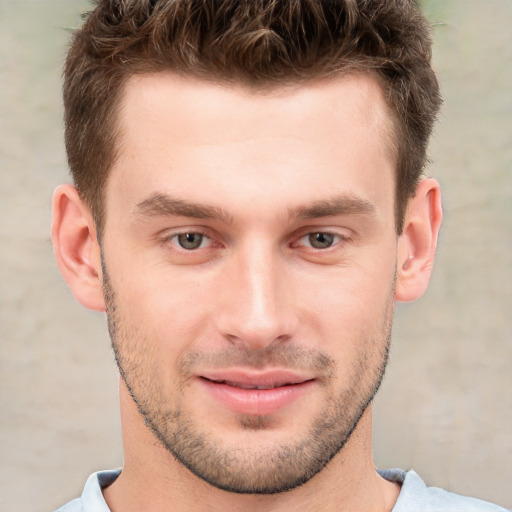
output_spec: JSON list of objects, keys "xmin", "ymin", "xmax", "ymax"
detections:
[{"xmin": 198, "ymin": 370, "xmax": 315, "ymax": 415}]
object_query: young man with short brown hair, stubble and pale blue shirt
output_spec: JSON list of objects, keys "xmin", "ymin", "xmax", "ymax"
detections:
[{"xmin": 53, "ymin": 0, "xmax": 508, "ymax": 512}]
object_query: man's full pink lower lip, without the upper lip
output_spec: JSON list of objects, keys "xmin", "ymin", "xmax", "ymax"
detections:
[{"xmin": 199, "ymin": 378, "xmax": 314, "ymax": 415}]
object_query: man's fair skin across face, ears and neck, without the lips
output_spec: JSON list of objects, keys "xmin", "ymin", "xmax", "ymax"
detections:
[{"xmin": 53, "ymin": 74, "xmax": 441, "ymax": 511}]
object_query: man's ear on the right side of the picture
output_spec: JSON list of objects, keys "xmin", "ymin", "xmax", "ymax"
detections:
[{"xmin": 395, "ymin": 178, "xmax": 443, "ymax": 301}]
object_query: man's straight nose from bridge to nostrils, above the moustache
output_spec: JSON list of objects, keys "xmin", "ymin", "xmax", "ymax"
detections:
[{"xmin": 218, "ymin": 244, "xmax": 297, "ymax": 350}]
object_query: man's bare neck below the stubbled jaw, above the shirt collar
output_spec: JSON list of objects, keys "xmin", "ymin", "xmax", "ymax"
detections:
[{"xmin": 103, "ymin": 380, "xmax": 399, "ymax": 512}]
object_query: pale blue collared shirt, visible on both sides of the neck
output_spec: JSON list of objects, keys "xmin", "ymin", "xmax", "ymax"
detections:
[{"xmin": 56, "ymin": 469, "xmax": 507, "ymax": 512}]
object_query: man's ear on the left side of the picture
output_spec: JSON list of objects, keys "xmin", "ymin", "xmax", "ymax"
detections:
[{"xmin": 52, "ymin": 185, "xmax": 105, "ymax": 311}]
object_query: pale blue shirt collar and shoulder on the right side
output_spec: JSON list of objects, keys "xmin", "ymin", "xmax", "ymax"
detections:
[{"xmin": 379, "ymin": 469, "xmax": 507, "ymax": 512}]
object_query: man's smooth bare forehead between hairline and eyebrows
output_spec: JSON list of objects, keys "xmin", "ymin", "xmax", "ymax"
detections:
[{"xmin": 107, "ymin": 73, "xmax": 396, "ymax": 221}]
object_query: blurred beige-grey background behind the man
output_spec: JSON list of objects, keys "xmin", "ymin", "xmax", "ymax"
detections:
[{"xmin": 0, "ymin": 0, "xmax": 512, "ymax": 512}]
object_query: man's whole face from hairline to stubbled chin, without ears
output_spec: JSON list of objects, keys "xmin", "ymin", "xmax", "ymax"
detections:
[{"xmin": 102, "ymin": 74, "xmax": 397, "ymax": 493}]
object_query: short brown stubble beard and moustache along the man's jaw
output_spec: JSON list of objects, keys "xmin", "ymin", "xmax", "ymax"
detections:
[{"xmin": 103, "ymin": 268, "xmax": 394, "ymax": 494}]
